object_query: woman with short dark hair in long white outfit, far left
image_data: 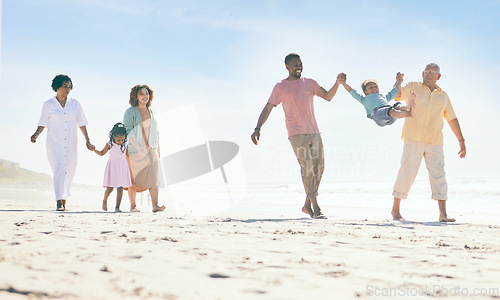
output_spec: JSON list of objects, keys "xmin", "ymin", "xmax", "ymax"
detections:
[{"xmin": 31, "ymin": 74, "xmax": 95, "ymax": 211}]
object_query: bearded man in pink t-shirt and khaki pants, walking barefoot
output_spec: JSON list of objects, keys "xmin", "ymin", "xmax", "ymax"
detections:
[{"xmin": 252, "ymin": 53, "xmax": 341, "ymax": 219}]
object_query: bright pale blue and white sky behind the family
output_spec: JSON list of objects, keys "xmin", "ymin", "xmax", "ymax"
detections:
[{"xmin": 0, "ymin": 0, "xmax": 500, "ymax": 186}]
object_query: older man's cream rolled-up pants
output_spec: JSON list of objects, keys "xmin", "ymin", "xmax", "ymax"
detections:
[{"xmin": 392, "ymin": 141, "xmax": 448, "ymax": 200}]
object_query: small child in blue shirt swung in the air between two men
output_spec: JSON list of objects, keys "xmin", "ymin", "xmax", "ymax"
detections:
[{"xmin": 340, "ymin": 72, "xmax": 417, "ymax": 126}]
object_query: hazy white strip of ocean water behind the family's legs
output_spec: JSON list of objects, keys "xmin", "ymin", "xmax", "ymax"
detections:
[{"xmin": 0, "ymin": 179, "xmax": 500, "ymax": 225}]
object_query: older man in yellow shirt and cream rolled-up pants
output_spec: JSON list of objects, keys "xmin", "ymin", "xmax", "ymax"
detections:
[{"xmin": 392, "ymin": 63, "xmax": 466, "ymax": 222}]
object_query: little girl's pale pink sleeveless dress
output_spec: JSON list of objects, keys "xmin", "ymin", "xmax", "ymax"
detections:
[{"xmin": 102, "ymin": 142, "xmax": 132, "ymax": 188}]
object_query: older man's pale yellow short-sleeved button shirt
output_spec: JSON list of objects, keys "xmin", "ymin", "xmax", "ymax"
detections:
[{"xmin": 401, "ymin": 82, "xmax": 456, "ymax": 145}]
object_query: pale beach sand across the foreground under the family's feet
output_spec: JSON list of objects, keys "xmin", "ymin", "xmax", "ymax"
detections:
[{"xmin": 0, "ymin": 194, "xmax": 500, "ymax": 299}]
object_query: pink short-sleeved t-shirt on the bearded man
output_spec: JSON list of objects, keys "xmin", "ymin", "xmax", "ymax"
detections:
[{"xmin": 267, "ymin": 78, "xmax": 320, "ymax": 137}]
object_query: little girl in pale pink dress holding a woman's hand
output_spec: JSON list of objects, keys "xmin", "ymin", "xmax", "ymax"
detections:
[{"xmin": 94, "ymin": 123, "xmax": 132, "ymax": 212}]
